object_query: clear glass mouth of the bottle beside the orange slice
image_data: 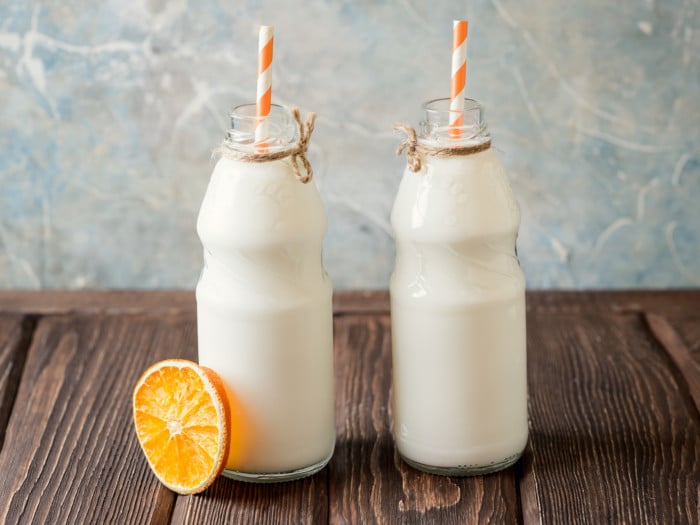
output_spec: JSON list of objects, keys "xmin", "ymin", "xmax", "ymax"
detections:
[{"xmin": 224, "ymin": 104, "xmax": 297, "ymax": 153}]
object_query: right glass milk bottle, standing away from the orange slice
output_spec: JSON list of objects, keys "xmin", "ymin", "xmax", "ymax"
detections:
[{"xmin": 391, "ymin": 99, "xmax": 528, "ymax": 475}]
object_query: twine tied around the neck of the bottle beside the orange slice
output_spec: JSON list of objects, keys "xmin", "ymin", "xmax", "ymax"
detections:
[{"xmin": 215, "ymin": 108, "xmax": 316, "ymax": 184}]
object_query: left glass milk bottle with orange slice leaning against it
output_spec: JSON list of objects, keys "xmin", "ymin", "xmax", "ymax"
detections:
[{"xmin": 197, "ymin": 104, "xmax": 335, "ymax": 482}]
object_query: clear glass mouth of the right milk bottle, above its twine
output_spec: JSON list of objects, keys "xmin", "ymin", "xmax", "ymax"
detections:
[{"xmin": 419, "ymin": 98, "xmax": 491, "ymax": 146}]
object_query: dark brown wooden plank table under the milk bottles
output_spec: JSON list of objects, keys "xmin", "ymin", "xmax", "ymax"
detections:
[{"xmin": 0, "ymin": 291, "xmax": 700, "ymax": 524}]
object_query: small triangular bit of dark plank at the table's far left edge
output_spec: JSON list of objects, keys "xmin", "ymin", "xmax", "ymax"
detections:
[{"xmin": 0, "ymin": 315, "xmax": 33, "ymax": 450}]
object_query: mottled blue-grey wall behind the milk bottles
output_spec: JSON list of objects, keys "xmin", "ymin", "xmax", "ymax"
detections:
[{"xmin": 0, "ymin": 0, "xmax": 700, "ymax": 288}]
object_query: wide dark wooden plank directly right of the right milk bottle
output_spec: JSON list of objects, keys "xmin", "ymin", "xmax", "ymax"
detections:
[{"xmin": 520, "ymin": 312, "xmax": 700, "ymax": 524}]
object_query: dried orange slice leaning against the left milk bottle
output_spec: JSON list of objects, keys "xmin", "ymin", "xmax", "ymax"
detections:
[{"xmin": 133, "ymin": 359, "xmax": 231, "ymax": 494}]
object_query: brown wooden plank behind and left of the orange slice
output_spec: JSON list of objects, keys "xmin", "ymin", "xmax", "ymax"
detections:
[{"xmin": 0, "ymin": 316, "xmax": 195, "ymax": 523}]
